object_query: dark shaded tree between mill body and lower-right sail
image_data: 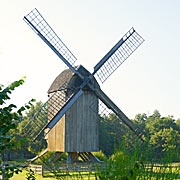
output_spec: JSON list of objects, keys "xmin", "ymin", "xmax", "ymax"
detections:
[{"xmin": 99, "ymin": 113, "xmax": 136, "ymax": 155}]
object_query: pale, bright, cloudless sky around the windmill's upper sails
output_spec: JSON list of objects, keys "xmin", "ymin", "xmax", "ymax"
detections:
[{"xmin": 0, "ymin": 0, "xmax": 180, "ymax": 119}]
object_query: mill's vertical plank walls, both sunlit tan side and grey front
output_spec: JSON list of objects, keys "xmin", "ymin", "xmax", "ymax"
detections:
[{"xmin": 47, "ymin": 91, "xmax": 99, "ymax": 152}]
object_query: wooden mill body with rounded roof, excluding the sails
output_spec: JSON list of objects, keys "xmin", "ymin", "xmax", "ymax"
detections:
[{"xmin": 47, "ymin": 66, "xmax": 99, "ymax": 152}]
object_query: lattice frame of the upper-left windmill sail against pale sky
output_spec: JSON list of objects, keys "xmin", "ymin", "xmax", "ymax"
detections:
[{"xmin": 23, "ymin": 8, "xmax": 77, "ymax": 66}]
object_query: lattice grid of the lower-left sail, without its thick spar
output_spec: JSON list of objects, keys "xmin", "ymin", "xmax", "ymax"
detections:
[{"xmin": 24, "ymin": 82, "xmax": 74, "ymax": 141}]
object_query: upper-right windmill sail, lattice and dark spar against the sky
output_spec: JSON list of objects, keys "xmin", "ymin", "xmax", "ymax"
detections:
[{"xmin": 93, "ymin": 28, "xmax": 144, "ymax": 83}]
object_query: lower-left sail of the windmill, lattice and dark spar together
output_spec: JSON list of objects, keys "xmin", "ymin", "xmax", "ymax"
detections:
[{"xmin": 24, "ymin": 82, "xmax": 83, "ymax": 141}]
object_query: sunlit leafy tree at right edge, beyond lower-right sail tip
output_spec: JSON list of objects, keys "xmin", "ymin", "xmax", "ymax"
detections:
[{"xmin": 134, "ymin": 110, "xmax": 180, "ymax": 159}]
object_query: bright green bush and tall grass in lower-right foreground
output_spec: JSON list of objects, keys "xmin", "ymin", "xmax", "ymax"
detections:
[{"xmin": 95, "ymin": 142, "xmax": 180, "ymax": 180}]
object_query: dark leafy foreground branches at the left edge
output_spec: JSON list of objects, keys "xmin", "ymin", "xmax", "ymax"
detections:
[{"xmin": 0, "ymin": 79, "xmax": 35, "ymax": 179}]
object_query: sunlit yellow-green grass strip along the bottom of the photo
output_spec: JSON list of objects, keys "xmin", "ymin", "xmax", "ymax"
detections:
[{"xmin": 10, "ymin": 164, "xmax": 180, "ymax": 180}]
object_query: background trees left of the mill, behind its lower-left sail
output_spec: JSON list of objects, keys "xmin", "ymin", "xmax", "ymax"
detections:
[{"xmin": 5, "ymin": 101, "xmax": 47, "ymax": 158}]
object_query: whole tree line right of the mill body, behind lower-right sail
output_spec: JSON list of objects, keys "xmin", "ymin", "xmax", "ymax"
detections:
[{"xmin": 100, "ymin": 110, "xmax": 180, "ymax": 161}]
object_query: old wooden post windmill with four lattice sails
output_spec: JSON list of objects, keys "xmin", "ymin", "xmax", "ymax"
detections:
[{"xmin": 24, "ymin": 8, "xmax": 144, "ymax": 162}]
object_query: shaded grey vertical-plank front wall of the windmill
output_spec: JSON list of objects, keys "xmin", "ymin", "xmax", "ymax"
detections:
[{"xmin": 65, "ymin": 91, "xmax": 99, "ymax": 152}]
